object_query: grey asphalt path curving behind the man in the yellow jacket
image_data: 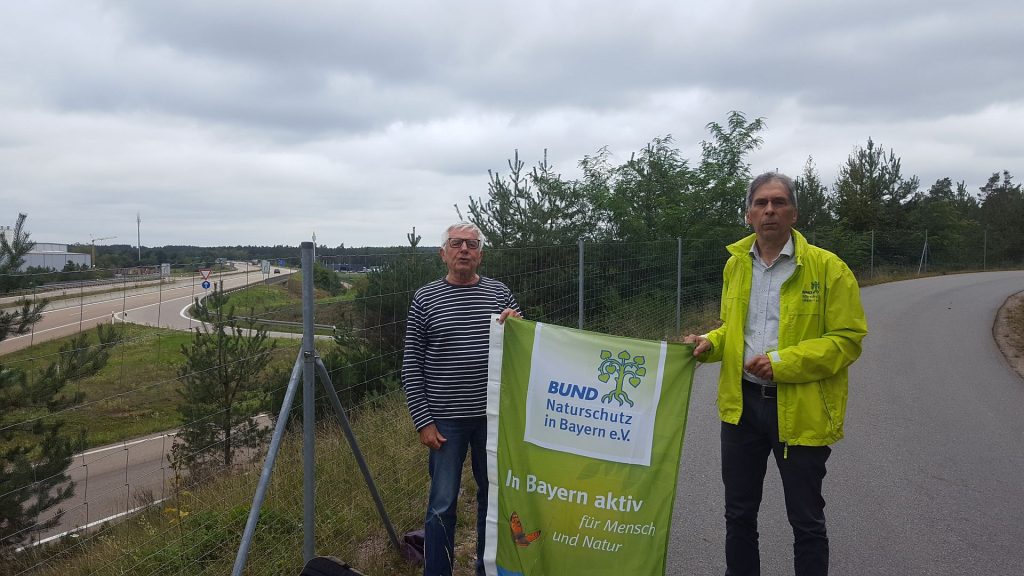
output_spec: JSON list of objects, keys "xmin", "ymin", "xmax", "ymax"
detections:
[{"xmin": 668, "ymin": 272, "xmax": 1024, "ymax": 576}]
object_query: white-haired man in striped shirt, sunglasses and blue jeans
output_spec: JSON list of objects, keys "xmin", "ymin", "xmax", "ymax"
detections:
[{"xmin": 401, "ymin": 222, "xmax": 520, "ymax": 576}]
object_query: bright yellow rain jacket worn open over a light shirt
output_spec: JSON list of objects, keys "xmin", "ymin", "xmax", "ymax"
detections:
[{"xmin": 699, "ymin": 231, "xmax": 867, "ymax": 446}]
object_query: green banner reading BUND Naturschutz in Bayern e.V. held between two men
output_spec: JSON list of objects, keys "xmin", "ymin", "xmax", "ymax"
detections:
[{"xmin": 484, "ymin": 319, "xmax": 695, "ymax": 576}]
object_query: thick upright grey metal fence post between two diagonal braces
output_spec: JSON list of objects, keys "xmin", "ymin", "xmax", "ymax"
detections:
[{"xmin": 300, "ymin": 242, "xmax": 316, "ymax": 562}]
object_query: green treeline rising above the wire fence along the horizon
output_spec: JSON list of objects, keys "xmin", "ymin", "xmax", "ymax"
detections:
[{"xmin": 72, "ymin": 111, "xmax": 1024, "ymax": 269}]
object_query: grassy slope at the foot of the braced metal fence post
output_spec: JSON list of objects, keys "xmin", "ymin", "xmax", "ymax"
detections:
[{"xmin": 15, "ymin": 393, "xmax": 487, "ymax": 576}]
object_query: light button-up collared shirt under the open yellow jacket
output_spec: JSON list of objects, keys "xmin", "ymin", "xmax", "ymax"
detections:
[{"xmin": 743, "ymin": 235, "xmax": 797, "ymax": 385}]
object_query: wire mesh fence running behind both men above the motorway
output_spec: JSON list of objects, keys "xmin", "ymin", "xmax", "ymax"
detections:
[{"xmin": 0, "ymin": 229, "xmax": 1022, "ymax": 576}]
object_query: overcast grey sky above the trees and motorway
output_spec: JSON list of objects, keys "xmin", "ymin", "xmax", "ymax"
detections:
[{"xmin": 0, "ymin": 0, "xmax": 1024, "ymax": 247}]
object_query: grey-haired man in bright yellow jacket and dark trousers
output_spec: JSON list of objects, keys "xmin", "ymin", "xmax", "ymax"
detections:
[{"xmin": 684, "ymin": 172, "xmax": 867, "ymax": 576}]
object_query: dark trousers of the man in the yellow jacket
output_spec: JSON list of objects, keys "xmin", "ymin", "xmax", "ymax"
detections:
[{"xmin": 722, "ymin": 381, "xmax": 831, "ymax": 576}]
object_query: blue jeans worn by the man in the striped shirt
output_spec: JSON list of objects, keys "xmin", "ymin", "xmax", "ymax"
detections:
[{"xmin": 423, "ymin": 416, "xmax": 487, "ymax": 576}]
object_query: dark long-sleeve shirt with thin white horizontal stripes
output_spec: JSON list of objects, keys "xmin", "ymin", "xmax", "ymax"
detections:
[{"xmin": 401, "ymin": 277, "xmax": 519, "ymax": 430}]
